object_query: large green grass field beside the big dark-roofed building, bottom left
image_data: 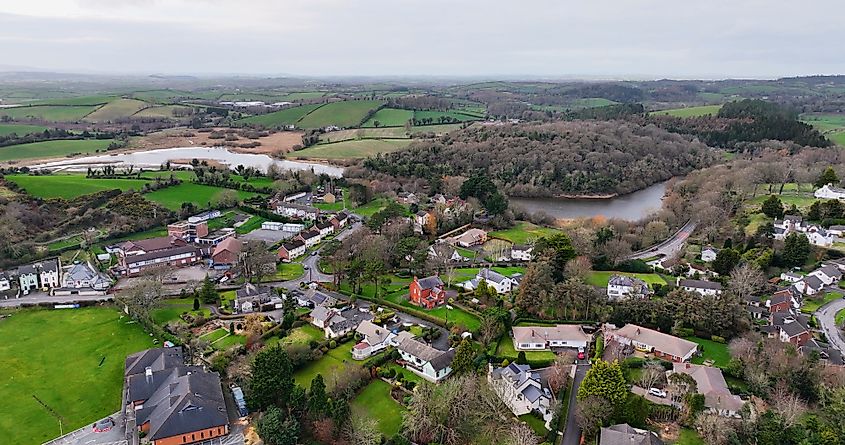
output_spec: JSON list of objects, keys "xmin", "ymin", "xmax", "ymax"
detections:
[{"xmin": 0, "ymin": 308, "xmax": 153, "ymax": 445}]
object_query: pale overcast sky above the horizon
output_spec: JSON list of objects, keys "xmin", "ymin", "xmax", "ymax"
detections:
[{"xmin": 0, "ymin": 0, "xmax": 845, "ymax": 78}]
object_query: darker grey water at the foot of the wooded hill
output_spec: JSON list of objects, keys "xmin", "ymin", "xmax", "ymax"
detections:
[{"xmin": 510, "ymin": 181, "xmax": 669, "ymax": 221}]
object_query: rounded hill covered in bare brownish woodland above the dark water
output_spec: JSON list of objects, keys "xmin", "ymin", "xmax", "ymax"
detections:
[{"xmin": 364, "ymin": 121, "xmax": 719, "ymax": 196}]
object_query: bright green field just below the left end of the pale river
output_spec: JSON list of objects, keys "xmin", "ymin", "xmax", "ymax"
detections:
[{"xmin": 6, "ymin": 175, "xmax": 147, "ymax": 199}]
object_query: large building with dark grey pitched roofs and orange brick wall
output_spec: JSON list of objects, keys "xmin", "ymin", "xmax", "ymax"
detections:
[{"xmin": 124, "ymin": 348, "xmax": 229, "ymax": 445}]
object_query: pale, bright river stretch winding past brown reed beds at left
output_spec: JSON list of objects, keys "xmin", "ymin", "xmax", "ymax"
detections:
[{"xmin": 31, "ymin": 147, "xmax": 343, "ymax": 177}]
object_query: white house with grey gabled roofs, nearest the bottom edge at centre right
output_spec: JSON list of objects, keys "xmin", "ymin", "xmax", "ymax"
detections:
[{"xmin": 487, "ymin": 363, "xmax": 554, "ymax": 424}]
